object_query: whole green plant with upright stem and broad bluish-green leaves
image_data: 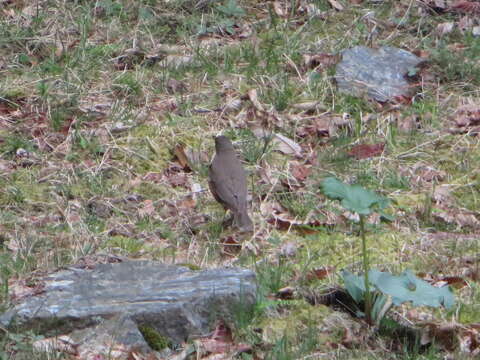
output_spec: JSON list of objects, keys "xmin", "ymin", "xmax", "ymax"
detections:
[{"xmin": 321, "ymin": 178, "xmax": 454, "ymax": 325}]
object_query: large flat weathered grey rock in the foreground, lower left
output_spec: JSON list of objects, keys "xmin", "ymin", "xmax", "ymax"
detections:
[{"xmin": 0, "ymin": 261, "xmax": 256, "ymax": 342}]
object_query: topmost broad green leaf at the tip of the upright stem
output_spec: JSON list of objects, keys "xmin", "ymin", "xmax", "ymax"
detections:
[{"xmin": 321, "ymin": 177, "xmax": 389, "ymax": 215}]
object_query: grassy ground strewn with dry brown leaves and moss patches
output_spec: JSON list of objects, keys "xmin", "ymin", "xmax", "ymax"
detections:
[{"xmin": 0, "ymin": 0, "xmax": 480, "ymax": 359}]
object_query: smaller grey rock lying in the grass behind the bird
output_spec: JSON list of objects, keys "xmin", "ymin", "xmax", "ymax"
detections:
[{"xmin": 335, "ymin": 46, "xmax": 423, "ymax": 102}]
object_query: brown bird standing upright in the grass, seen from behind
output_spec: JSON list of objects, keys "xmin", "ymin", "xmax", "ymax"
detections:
[{"xmin": 208, "ymin": 135, "xmax": 253, "ymax": 232}]
